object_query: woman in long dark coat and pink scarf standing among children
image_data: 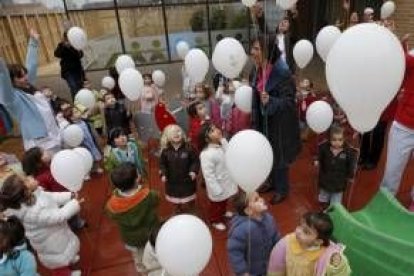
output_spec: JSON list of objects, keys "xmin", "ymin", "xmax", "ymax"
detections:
[{"xmin": 250, "ymin": 36, "xmax": 301, "ymax": 204}]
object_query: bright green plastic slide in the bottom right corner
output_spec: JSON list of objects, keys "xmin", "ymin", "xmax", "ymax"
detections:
[{"xmin": 329, "ymin": 190, "xmax": 414, "ymax": 276}]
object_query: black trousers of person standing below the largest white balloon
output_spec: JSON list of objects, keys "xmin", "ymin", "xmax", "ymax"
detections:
[{"xmin": 359, "ymin": 121, "xmax": 388, "ymax": 166}]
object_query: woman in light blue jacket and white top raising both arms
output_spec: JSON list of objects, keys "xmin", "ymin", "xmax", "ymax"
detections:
[{"xmin": 0, "ymin": 30, "xmax": 61, "ymax": 153}]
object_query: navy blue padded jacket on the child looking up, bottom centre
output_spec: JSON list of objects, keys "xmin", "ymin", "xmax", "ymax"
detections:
[{"xmin": 227, "ymin": 212, "xmax": 279, "ymax": 276}]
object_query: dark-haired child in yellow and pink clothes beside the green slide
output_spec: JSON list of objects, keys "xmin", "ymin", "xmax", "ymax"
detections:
[{"xmin": 267, "ymin": 213, "xmax": 351, "ymax": 276}]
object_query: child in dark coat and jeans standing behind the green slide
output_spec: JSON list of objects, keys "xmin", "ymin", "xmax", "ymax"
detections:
[{"xmin": 315, "ymin": 125, "xmax": 356, "ymax": 204}]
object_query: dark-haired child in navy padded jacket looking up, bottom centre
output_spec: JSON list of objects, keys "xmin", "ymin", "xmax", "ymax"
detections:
[{"xmin": 227, "ymin": 192, "xmax": 279, "ymax": 275}]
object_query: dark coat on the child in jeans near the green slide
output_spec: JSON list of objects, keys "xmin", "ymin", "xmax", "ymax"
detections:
[{"xmin": 318, "ymin": 141, "xmax": 357, "ymax": 193}]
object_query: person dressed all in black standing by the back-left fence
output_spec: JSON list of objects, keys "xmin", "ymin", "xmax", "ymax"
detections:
[{"xmin": 55, "ymin": 32, "xmax": 85, "ymax": 99}]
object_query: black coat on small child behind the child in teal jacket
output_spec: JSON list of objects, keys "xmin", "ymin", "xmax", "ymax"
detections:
[{"xmin": 104, "ymin": 103, "xmax": 131, "ymax": 134}]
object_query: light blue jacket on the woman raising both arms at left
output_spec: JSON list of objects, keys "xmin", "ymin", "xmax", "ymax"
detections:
[{"xmin": 0, "ymin": 39, "xmax": 48, "ymax": 140}]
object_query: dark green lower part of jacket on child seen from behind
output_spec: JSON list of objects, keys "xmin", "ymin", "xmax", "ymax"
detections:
[{"xmin": 107, "ymin": 190, "xmax": 159, "ymax": 247}]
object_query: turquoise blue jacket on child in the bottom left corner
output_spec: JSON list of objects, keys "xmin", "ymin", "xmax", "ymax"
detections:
[{"xmin": 0, "ymin": 244, "xmax": 37, "ymax": 276}]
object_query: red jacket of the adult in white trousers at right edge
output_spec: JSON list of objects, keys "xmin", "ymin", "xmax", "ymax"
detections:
[{"xmin": 395, "ymin": 45, "xmax": 414, "ymax": 129}]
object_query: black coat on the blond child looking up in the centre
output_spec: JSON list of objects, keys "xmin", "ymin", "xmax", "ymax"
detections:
[{"xmin": 160, "ymin": 144, "xmax": 199, "ymax": 198}]
